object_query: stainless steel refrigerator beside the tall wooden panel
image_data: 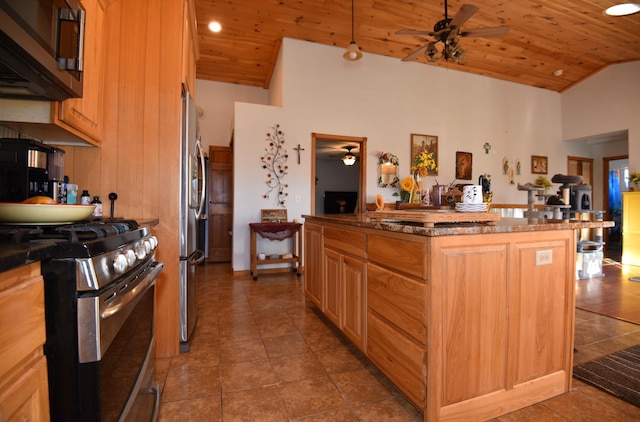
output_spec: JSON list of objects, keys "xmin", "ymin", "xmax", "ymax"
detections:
[{"xmin": 180, "ymin": 90, "xmax": 207, "ymax": 352}]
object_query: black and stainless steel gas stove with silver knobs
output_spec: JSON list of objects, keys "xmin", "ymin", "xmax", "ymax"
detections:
[{"xmin": 0, "ymin": 219, "xmax": 164, "ymax": 422}]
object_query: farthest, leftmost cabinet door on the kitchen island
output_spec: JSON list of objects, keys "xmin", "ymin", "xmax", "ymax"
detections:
[{"xmin": 304, "ymin": 223, "xmax": 324, "ymax": 312}]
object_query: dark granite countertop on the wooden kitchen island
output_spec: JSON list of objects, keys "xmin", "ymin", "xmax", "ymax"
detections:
[{"xmin": 302, "ymin": 213, "xmax": 614, "ymax": 237}]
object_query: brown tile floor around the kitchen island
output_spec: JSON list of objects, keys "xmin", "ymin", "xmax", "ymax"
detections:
[{"xmin": 156, "ymin": 264, "xmax": 640, "ymax": 422}]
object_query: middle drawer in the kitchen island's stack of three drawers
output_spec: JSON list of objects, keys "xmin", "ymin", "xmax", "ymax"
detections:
[{"xmin": 367, "ymin": 264, "xmax": 427, "ymax": 345}]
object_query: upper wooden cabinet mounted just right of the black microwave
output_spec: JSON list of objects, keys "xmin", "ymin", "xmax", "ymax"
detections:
[{"xmin": 52, "ymin": 0, "xmax": 107, "ymax": 144}]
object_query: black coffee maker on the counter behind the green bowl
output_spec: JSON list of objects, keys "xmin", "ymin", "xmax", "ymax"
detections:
[{"xmin": 0, "ymin": 138, "xmax": 64, "ymax": 202}]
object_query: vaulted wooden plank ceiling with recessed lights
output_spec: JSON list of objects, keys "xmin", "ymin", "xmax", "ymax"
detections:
[{"xmin": 195, "ymin": 0, "xmax": 640, "ymax": 92}]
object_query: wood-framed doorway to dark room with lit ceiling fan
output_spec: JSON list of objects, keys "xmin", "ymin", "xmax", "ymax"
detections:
[{"xmin": 311, "ymin": 133, "xmax": 367, "ymax": 215}]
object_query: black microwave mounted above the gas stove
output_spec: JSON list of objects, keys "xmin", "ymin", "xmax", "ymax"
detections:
[{"xmin": 0, "ymin": 0, "xmax": 85, "ymax": 101}]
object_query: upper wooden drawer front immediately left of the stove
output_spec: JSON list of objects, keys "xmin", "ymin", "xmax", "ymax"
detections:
[{"xmin": 0, "ymin": 264, "xmax": 46, "ymax": 380}]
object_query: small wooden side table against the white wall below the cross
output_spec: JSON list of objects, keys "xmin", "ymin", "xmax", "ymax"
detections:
[{"xmin": 249, "ymin": 222, "xmax": 302, "ymax": 281}]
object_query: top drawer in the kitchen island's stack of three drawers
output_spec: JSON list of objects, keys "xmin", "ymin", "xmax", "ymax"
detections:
[{"xmin": 367, "ymin": 235, "xmax": 427, "ymax": 279}]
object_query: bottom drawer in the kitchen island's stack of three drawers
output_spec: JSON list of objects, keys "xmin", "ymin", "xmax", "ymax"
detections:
[{"xmin": 367, "ymin": 312, "xmax": 427, "ymax": 409}]
